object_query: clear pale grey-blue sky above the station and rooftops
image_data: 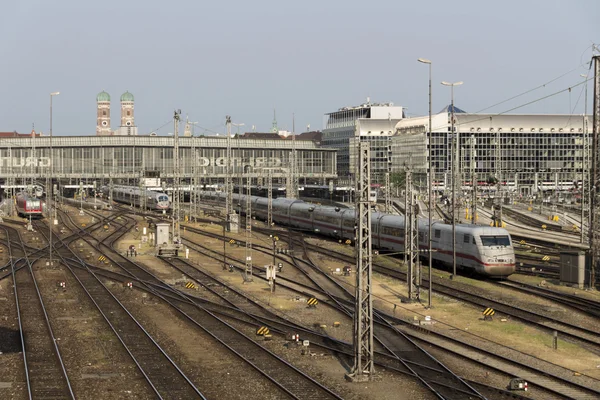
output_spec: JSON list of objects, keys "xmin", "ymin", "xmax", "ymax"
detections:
[{"xmin": 0, "ymin": 0, "xmax": 600, "ymax": 136}]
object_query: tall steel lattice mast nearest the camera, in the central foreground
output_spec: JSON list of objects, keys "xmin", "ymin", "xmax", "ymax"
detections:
[{"xmin": 348, "ymin": 141, "xmax": 375, "ymax": 382}]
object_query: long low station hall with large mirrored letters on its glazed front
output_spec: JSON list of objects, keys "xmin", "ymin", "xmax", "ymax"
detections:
[{"xmin": 0, "ymin": 135, "xmax": 337, "ymax": 188}]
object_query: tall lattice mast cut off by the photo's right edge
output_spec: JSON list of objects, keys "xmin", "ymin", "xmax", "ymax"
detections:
[{"xmin": 588, "ymin": 55, "xmax": 600, "ymax": 287}]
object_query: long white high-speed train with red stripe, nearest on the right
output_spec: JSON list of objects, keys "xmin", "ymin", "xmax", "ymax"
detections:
[{"xmin": 198, "ymin": 192, "xmax": 515, "ymax": 278}]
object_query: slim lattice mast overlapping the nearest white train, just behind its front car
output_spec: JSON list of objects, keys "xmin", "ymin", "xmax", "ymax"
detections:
[{"xmin": 404, "ymin": 167, "xmax": 420, "ymax": 301}]
